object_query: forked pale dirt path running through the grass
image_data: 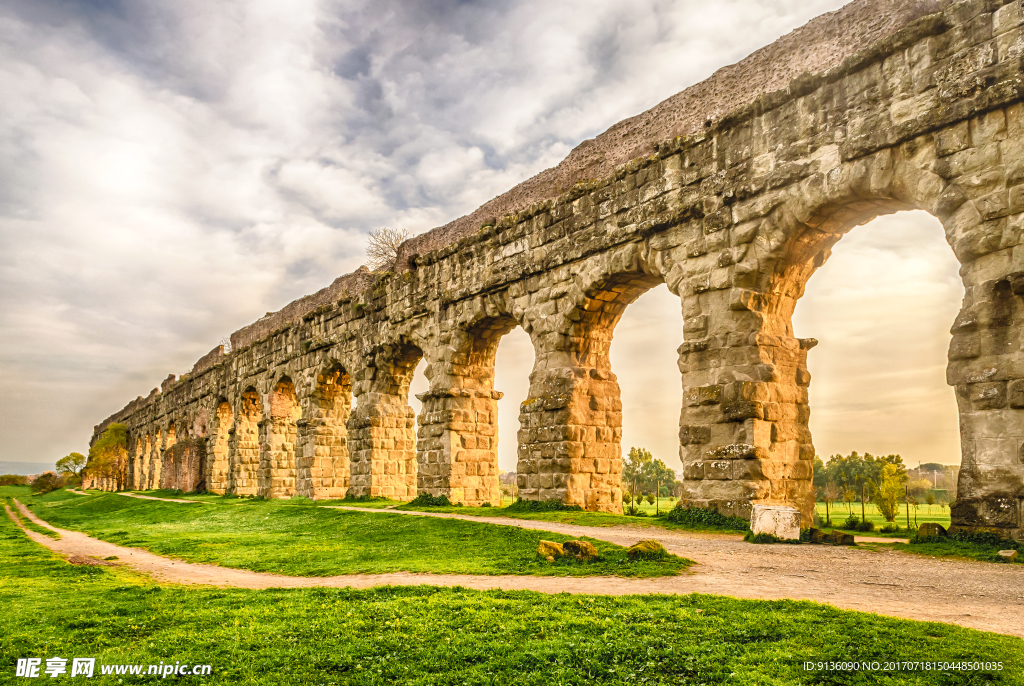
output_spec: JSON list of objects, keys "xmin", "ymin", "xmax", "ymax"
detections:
[{"xmin": 9, "ymin": 501, "xmax": 1024, "ymax": 638}]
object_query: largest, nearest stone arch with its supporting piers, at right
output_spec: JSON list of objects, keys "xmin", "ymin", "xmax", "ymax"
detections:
[{"xmin": 680, "ymin": 123, "xmax": 1024, "ymax": 535}]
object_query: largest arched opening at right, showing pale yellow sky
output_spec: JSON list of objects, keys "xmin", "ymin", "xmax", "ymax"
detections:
[{"xmin": 793, "ymin": 211, "xmax": 965, "ymax": 522}]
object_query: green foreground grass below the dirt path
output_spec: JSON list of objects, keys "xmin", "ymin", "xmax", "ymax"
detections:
[{"xmin": 0, "ymin": 507, "xmax": 1024, "ymax": 686}]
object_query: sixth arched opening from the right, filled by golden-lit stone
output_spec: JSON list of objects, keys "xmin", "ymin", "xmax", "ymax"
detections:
[{"xmin": 257, "ymin": 377, "xmax": 302, "ymax": 498}]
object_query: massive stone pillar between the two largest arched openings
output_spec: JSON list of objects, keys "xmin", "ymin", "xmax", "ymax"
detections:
[{"xmin": 679, "ymin": 303, "xmax": 817, "ymax": 526}]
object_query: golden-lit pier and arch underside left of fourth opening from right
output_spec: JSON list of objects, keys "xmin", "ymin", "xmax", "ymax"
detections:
[{"xmin": 348, "ymin": 336, "xmax": 419, "ymax": 500}]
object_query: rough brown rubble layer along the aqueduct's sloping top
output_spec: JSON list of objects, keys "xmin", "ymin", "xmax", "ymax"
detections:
[{"xmin": 201, "ymin": 0, "xmax": 940, "ymax": 366}]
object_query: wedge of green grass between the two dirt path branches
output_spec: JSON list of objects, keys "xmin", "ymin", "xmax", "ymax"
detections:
[{"xmin": 19, "ymin": 490, "xmax": 691, "ymax": 576}]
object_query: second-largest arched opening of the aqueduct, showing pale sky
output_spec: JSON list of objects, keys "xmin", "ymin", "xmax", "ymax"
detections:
[{"xmin": 609, "ymin": 284, "xmax": 683, "ymax": 510}]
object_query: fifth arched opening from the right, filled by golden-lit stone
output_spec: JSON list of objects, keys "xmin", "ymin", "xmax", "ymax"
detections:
[{"xmin": 296, "ymin": 362, "xmax": 352, "ymax": 499}]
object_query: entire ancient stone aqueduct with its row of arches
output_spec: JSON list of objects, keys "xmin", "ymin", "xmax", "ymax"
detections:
[{"xmin": 86, "ymin": 0, "xmax": 1024, "ymax": 537}]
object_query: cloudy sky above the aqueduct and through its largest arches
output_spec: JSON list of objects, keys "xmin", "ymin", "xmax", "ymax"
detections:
[{"xmin": 0, "ymin": 0, "xmax": 962, "ymax": 479}]
